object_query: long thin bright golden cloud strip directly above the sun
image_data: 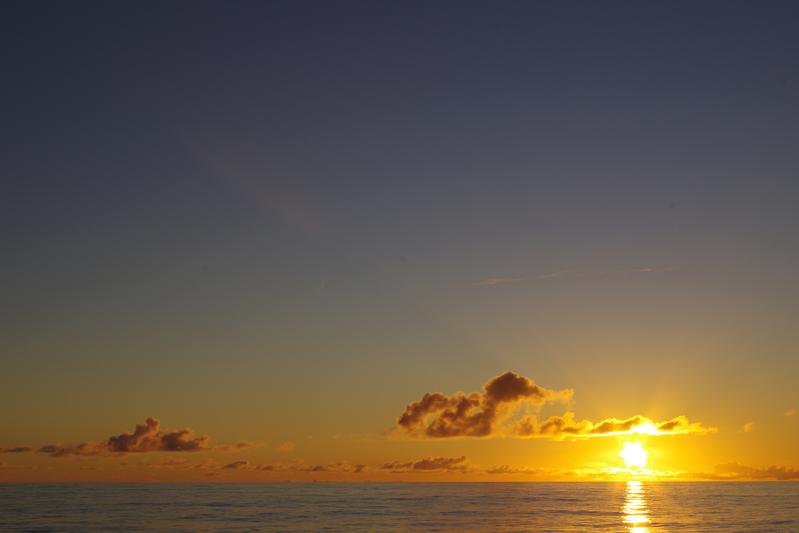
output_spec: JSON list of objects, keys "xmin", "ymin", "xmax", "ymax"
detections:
[{"xmin": 512, "ymin": 411, "xmax": 715, "ymax": 438}]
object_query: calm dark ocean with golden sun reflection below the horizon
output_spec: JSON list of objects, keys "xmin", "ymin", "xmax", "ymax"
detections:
[{"xmin": 0, "ymin": 482, "xmax": 799, "ymax": 532}]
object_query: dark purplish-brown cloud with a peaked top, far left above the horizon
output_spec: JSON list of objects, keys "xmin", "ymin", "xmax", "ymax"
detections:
[{"xmin": 38, "ymin": 417, "xmax": 210, "ymax": 457}]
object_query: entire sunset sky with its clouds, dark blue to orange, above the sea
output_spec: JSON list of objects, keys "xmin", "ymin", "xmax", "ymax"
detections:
[{"xmin": 0, "ymin": 1, "xmax": 799, "ymax": 481}]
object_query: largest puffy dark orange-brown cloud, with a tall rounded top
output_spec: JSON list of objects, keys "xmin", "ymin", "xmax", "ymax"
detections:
[{"xmin": 397, "ymin": 372, "xmax": 572, "ymax": 438}]
